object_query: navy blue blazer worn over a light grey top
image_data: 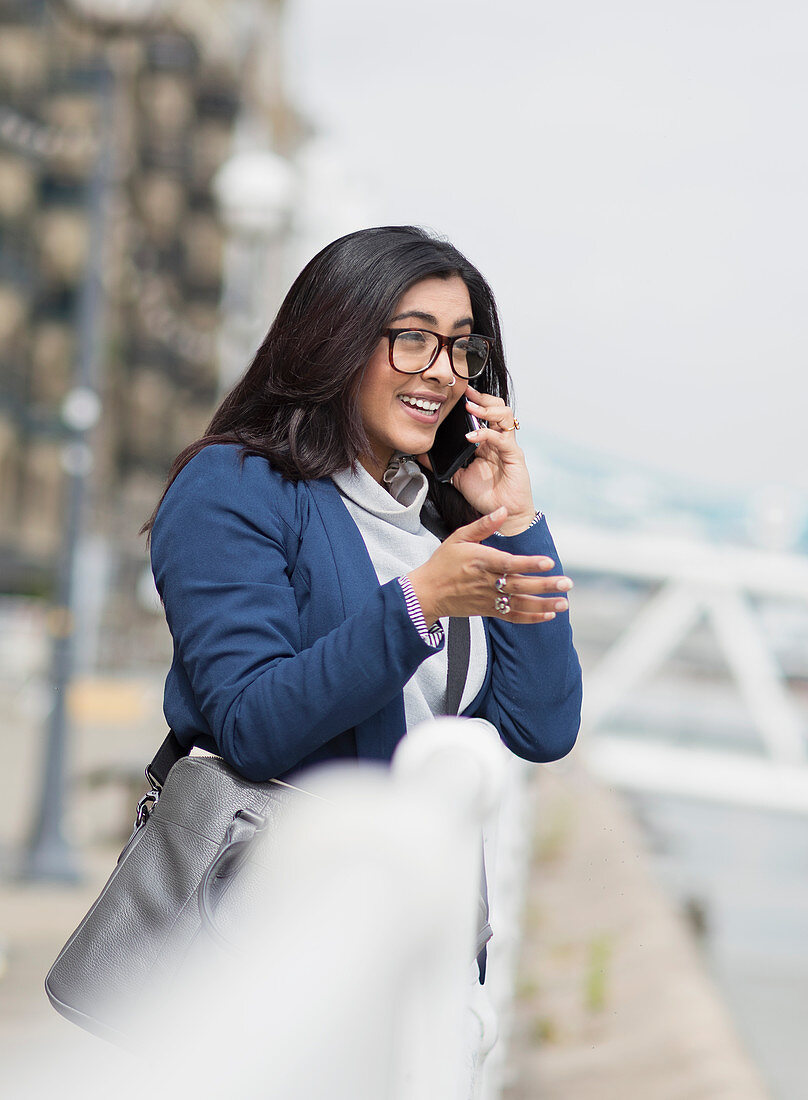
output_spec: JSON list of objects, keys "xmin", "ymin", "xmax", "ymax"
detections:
[{"xmin": 152, "ymin": 444, "xmax": 582, "ymax": 781}]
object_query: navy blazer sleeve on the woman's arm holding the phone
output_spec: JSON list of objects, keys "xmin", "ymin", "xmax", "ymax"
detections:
[{"xmin": 476, "ymin": 517, "xmax": 583, "ymax": 762}]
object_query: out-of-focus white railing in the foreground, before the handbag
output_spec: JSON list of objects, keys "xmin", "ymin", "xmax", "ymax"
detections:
[{"xmin": 9, "ymin": 718, "xmax": 536, "ymax": 1100}]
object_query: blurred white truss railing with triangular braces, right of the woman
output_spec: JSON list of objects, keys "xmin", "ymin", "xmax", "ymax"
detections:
[{"xmin": 556, "ymin": 525, "xmax": 808, "ymax": 813}]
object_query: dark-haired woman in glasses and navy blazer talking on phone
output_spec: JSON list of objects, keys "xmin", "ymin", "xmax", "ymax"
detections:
[{"xmin": 146, "ymin": 227, "xmax": 582, "ymax": 781}]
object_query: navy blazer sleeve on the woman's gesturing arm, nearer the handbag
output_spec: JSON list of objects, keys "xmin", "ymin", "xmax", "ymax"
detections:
[{"xmin": 152, "ymin": 447, "xmax": 435, "ymax": 781}]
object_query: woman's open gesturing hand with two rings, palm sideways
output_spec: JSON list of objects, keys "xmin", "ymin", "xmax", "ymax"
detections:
[{"xmin": 407, "ymin": 508, "xmax": 573, "ymax": 627}]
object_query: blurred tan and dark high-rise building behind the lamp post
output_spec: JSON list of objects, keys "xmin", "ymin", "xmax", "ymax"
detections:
[{"xmin": 0, "ymin": 0, "xmax": 297, "ymax": 657}]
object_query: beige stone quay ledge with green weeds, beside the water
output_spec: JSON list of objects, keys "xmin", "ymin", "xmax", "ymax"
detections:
[{"xmin": 505, "ymin": 763, "xmax": 768, "ymax": 1100}]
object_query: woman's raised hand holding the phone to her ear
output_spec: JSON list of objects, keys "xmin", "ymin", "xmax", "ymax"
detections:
[{"xmin": 452, "ymin": 386, "xmax": 535, "ymax": 535}]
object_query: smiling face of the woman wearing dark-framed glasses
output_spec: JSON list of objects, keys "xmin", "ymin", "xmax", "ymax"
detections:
[{"xmin": 359, "ymin": 275, "xmax": 473, "ymax": 482}]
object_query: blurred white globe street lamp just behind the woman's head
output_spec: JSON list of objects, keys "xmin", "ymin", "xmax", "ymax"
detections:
[{"xmin": 213, "ymin": 147, "xmax": 295, "ymax": 391}]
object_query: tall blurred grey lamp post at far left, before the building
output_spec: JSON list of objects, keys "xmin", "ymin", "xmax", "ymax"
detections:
[{"xmin": 20, "ymin": 0, "xmax": 169, "ymax": 882}]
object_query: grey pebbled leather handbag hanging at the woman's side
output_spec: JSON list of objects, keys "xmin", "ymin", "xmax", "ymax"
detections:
[{"xmin": 45, "ymin": 734, "xmax": 303, "ymax": 1045}]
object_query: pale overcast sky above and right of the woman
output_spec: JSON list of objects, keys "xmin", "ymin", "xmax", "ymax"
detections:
[{"xmin": 288, "ymin": 0, "xmax": 808, "ymax": 499}]
